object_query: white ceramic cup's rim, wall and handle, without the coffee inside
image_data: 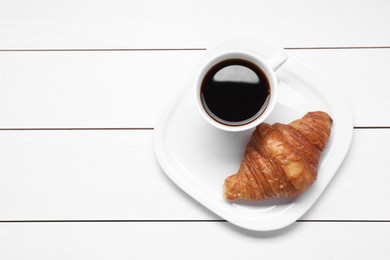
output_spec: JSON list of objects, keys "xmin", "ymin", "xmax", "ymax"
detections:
[{"xmin": 195, "ymin": 38, "xmax": 288, "ymax": 132}]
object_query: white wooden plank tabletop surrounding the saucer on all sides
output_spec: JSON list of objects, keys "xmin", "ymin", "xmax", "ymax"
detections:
[{"xmin": 0, "ymin": 0, "xmax": 390, "ymax": 260}]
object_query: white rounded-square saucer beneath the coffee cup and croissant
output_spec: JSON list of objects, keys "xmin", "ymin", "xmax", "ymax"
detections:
[{"xmin": 154, "ymin": 39, "xmax": 353, "ymax": 231}]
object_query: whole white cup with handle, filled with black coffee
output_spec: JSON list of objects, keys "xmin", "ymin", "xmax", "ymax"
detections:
[{"xmin": 195, "ymin": 39, "xmax": 287, "ymax": 132}]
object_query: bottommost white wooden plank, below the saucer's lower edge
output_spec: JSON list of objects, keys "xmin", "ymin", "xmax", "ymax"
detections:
[{"xmin": 0, "ymin": 223, "xmax": 390, "ymax": 260}]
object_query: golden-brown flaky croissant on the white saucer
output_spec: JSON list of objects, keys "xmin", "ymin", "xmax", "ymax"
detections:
[{"xmin": 224, "ymin": 111, "xmax": 333, "ymax": 200}]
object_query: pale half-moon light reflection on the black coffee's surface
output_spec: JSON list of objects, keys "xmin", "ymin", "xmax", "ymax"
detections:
[{"xmin": 214, "ymin": 65, "xmax": 259, "ymax": 83}]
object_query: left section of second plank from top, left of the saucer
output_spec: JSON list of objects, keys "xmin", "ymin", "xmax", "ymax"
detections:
[{"xmin": 0, "ymin": 51, "xmax": 201, "ymax": 128}]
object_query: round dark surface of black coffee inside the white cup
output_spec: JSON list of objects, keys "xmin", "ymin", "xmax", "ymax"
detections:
[{"xmin": 201, "ymin": 59, "xmax": 270, "ymax": 125}]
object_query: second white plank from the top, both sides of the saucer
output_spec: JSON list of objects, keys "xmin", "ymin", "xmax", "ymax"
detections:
[{"xmin": 0, "ymin": 49, "xmax": 390, "ymax": 128}]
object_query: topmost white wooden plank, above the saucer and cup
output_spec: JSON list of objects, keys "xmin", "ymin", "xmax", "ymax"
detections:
[{"xmin": 0, "ymin": 0, "xmax": 390, "ymax": 49}]
